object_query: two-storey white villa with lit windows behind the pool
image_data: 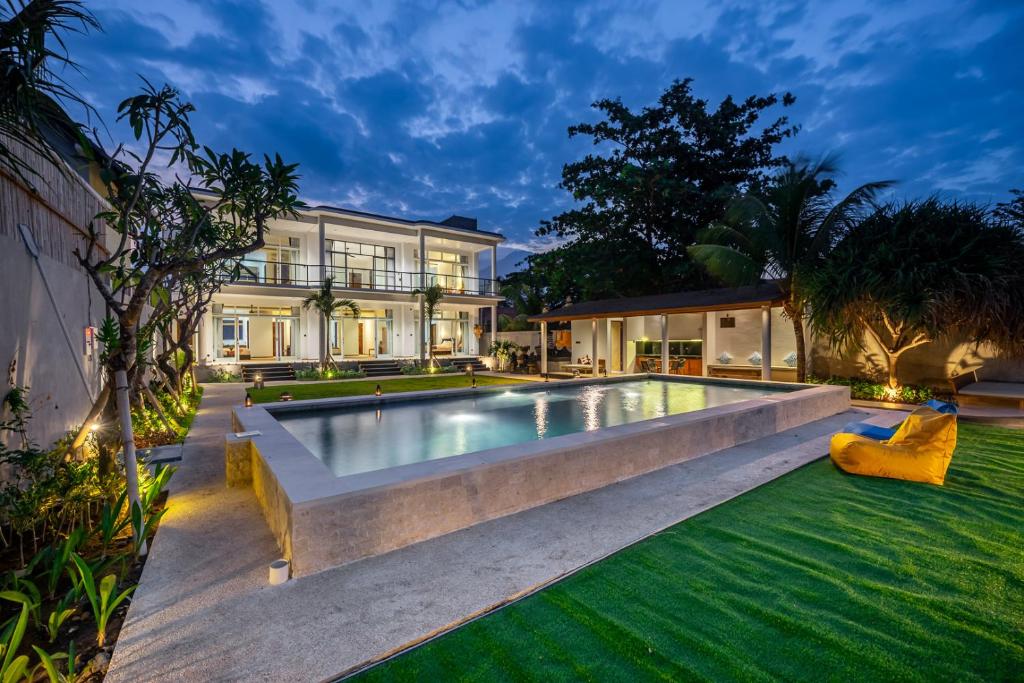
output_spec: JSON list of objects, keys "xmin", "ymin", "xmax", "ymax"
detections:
[{"xmin": 198, "ymin": 192, "xmax": 504, "ymax": 376}]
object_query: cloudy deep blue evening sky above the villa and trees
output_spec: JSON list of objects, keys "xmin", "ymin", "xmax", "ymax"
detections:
[{"xmin": 59, "ymin": 0, "xmax": 1024, "ymax": 249}]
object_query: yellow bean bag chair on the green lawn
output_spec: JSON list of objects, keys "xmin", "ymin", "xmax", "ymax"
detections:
[{"xmin": 829, "ymin": 408, "xmax": 956, "ymax": 486}]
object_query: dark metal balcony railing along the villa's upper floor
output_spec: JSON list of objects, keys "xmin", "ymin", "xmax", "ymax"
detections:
[{"xmin": 224, "ymin": 261, "xmax": 497, "ymax": 296}]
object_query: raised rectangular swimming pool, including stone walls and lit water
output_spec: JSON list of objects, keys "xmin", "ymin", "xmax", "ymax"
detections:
[{"xmin": 230, "ymin": 375, "xmax": 850, "ymax": 575}]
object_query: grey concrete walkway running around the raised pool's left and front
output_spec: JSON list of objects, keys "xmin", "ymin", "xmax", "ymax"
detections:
[{"xmin": 106, "ymin": 385, "xmax": 902, "ymax": 683}]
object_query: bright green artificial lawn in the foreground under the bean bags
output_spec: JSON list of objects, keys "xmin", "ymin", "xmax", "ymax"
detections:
[{"xmin": 360, "ymin": 424, "xmax": 1024, "ymax": 681}]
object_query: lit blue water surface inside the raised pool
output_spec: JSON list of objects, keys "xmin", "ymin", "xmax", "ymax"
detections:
[{"xmin": 275, "ymin": 380, "xmax": 787, "ymax": 476}]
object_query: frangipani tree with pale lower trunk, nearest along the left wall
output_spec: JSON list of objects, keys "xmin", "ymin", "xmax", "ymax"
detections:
[{"xmin": 75, "ymin": 82, "xmax": 301, "ymax": 536}]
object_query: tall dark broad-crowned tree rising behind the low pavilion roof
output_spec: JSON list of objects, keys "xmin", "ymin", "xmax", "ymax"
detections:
[{"xmin": 530, "ymin": 79, "xmax": 796, "ymax": 300}]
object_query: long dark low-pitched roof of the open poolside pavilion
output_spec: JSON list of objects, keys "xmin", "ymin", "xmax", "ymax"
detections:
[{"xmin": 529, "ymin": 281, "xmax": 784, "ymax": 322}]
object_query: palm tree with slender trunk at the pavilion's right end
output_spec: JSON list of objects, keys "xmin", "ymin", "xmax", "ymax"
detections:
[{"xmin": 688, "ymin": 156, "xmax": 893, "ymax": 382}]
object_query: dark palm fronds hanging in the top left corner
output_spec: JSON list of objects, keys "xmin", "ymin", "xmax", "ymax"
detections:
[{"xmin": 0, "ymin": 0, "xmax": 99, "ymax": 187}]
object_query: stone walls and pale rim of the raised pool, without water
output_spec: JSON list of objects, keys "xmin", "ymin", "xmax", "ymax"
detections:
[{"xmin": 225, "ymin": 375, "xmax": 849, "ymax": 577}]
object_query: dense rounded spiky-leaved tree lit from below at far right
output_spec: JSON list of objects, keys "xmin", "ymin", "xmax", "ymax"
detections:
[{"xmin": 807, "ymin": 198, "xmax": 1024, "ymax": 389}]
